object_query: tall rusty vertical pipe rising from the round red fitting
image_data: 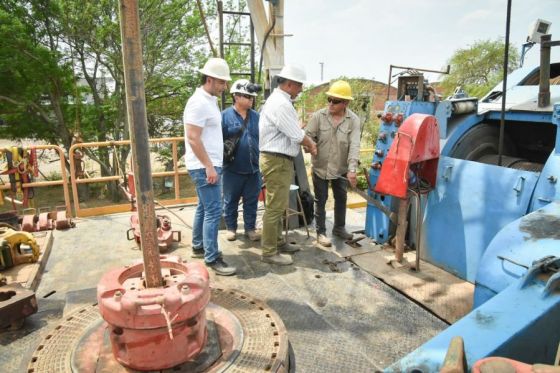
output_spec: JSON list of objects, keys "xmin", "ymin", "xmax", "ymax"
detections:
[{"xmin": 119, "ymin": 0, "xmax": 162, "ymax": 288}]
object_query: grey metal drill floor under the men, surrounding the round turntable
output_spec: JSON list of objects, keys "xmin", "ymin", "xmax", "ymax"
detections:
[{"xmin": 0, "ymin": 206, "xmax": 447, "ymax": 372}]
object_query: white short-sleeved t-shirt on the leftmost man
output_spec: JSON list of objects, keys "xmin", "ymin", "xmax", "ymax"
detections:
[{"xmin": 183, "ymin": 87, "xmax": 224, "ymax": 170}]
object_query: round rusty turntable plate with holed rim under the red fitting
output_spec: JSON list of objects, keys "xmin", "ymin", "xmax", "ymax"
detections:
[{"xmin": 28, "ymin": 289, "xmax": 288, "ymax": 373}]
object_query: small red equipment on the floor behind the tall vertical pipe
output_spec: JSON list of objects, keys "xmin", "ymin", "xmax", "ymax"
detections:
[{"xmin": 121, "ymin": 173, "xmax": 181, "ymax": 253}]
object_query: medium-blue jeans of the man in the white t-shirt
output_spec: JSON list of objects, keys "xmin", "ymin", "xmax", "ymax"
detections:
[{"xmin": 189, "ymin": 167, "xmax": 222, "ymax": 263}]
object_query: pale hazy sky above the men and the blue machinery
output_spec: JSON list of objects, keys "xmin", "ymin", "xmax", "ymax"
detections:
[{"xmin": 284, "ymin": 0, "xmax": 560, "ymax": 84}]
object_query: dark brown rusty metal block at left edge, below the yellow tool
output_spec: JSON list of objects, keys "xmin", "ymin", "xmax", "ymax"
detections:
[{"xmin": 0, "ymin": 283, "xmax": 37, "ymax": 329}]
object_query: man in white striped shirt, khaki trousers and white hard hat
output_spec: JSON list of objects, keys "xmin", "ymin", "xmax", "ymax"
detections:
[{"xmin": 259, "ymin": 65, "xmax": 317, "ymax": 265}]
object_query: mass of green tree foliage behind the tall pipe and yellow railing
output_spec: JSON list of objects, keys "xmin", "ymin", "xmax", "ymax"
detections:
[{"xmin": 0, "ymin": 0, "xmax": 252, "ymax": 166}]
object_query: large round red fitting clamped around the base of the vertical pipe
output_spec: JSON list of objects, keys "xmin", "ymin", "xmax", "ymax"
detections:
[{"xmin": 97, "ymin": 256, "xmax": 210, "ymax": 370}]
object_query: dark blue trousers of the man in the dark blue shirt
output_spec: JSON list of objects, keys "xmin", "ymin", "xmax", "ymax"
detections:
[{"xmin": 224, "ymin": 168, "xmax": 261, "ymax": 232}]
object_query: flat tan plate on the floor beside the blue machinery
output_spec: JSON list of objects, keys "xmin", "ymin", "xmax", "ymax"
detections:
[{"xmin": 352, "ymin": 245, "xmax": 474, "ymax": 323}]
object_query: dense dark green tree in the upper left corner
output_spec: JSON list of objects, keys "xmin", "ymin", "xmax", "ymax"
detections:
[{"xmin": 0, "ymin": 0, "xmax": 72, "ymax": 147}]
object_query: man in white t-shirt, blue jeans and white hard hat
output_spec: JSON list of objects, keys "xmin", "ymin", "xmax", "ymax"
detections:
[{"xmin": 183, "ymin": 58, "xmax": 236, "ymax": 276}]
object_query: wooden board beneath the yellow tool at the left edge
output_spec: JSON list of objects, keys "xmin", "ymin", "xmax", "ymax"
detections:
[{"xmin": 2, "ymin": 231, "xmax": 54, "ymax": 291}]
